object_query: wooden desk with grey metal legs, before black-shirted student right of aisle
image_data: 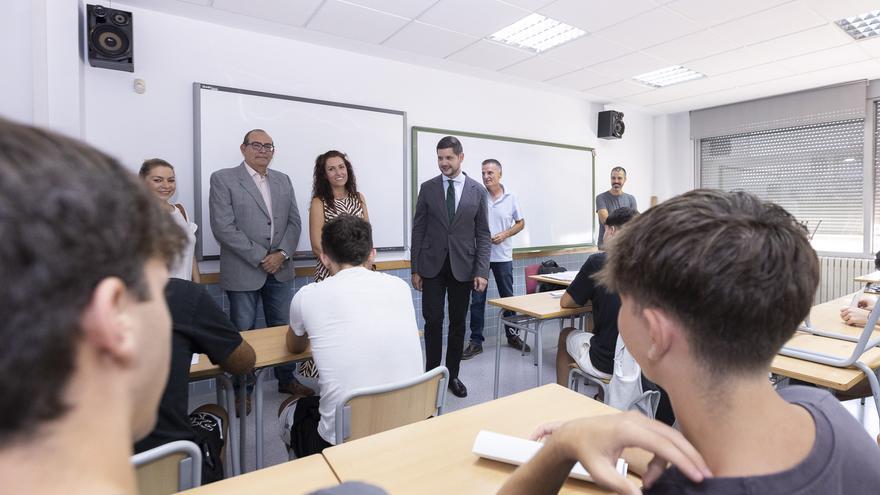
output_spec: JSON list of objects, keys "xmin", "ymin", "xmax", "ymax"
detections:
[{"xmin": 489, "ymin": 292, "xmax": 592, "ymax": 399}]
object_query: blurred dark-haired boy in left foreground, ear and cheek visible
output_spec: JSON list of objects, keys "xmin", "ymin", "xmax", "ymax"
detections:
[{"xmin": 0, "ymin": 119, "xmax": 186, "ymax": 494}]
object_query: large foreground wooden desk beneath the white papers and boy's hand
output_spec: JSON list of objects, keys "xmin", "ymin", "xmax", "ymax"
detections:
[{"xmin": 324, "ymin": 384, "xmax": 650, "ymax": 495}]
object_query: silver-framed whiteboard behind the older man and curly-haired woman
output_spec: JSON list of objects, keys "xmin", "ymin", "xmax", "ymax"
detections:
[{"xmin": 193, "ymin": 83, "xmax": 406, "ymax": 259}]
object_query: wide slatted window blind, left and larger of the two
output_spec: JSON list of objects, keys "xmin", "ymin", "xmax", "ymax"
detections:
[{"xmin": 700, "ymin": 119, "xmax": 868, "ymax": 253}]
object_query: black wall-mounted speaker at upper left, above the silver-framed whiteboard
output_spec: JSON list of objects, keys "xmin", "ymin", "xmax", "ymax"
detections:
[{"xmin": 86, "ymin": 5, "xmax": 134, "ymax": 72}]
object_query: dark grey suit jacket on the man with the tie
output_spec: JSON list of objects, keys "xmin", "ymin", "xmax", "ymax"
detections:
[{"xmin": 410, "ymin": 175, "xmax": 492, "ymax": 282}]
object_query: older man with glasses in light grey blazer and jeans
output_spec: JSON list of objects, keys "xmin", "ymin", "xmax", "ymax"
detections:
[{"xmin": 209, "ymin": 129, "xmax": 311, "ymax": 404}]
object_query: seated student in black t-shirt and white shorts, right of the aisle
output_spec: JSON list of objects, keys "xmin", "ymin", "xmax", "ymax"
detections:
[{"xmin": 556, "ymin": 207, "xmax": 638, "ymax": 392}]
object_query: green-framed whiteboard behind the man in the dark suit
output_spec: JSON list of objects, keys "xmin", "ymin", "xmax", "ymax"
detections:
[{"xmin": 412, "ymin": 127, "xmax": 595, "ymax": 251}]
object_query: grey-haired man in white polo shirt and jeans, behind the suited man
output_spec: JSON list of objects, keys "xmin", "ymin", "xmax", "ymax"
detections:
[{"xmin": 461, "ymin": 158, "xmax": 531, "ymax": 359}]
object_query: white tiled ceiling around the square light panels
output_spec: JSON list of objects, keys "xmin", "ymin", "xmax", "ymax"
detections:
[{"xmin": 125, "ymin": 0, "xmax": 880, "ymax": 113}]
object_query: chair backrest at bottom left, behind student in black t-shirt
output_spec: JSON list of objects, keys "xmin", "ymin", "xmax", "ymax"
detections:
[{"xmin": 131, "ymin": 440, "xmax": 202, "ymax": 495}]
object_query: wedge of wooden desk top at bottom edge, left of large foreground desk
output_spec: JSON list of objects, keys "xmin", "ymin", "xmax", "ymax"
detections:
[{"xmin": 182, "ymin": 455, "xmax": 339, "ymax": 495}]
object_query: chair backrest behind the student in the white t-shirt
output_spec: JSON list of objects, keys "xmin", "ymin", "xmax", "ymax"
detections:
[{"xmin": 336, "ymin": 366, "xmax": 449, "ymax": 445}]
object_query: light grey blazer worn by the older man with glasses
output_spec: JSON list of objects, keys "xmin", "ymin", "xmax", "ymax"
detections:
[{"xmin": 208, "ymin": 162, "xmax": 302, "ymax": 291}]
